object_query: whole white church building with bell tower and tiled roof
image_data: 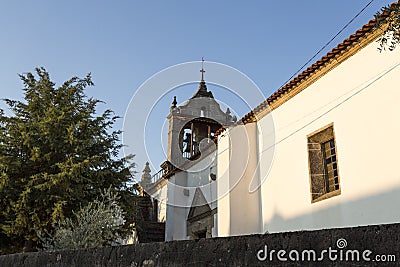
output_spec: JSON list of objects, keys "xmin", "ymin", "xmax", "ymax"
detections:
[{"xmin": 142, "ymin": 3, "xmax": 400, "ymax": 241}]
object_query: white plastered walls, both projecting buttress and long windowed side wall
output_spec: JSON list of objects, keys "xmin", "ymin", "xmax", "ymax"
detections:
[{"xmin": 217, "ymin": 33, "xmax": 400, "ymax": 236}]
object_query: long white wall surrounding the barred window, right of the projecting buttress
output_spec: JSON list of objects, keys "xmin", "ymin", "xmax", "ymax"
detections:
[{"xmin": 260, "ymin": 38, "xmax": 400, "ymax": 232}]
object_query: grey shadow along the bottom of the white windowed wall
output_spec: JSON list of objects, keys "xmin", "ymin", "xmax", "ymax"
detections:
[{"xmin": 264, "ymin": 187, "xmax": 400, "ymax": 233}]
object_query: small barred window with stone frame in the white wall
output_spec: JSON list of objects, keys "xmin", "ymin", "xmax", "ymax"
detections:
[{"xmin": 308, "ymin": 124, "xmax": 340, "ymax": 203}]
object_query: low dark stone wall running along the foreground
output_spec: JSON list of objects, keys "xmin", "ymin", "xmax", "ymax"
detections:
[{"xmin": 0, "ymin": 224, "xmax": 400, "ymax": 267}]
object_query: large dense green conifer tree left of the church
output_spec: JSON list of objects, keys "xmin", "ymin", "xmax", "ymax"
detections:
[{"xmin": 0, "ymin": 68, "xmax": 135, "ymax": 253}]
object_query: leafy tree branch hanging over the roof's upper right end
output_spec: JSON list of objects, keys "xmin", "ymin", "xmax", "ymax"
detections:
[{"xmin": 375, "ymin": 3, "xmax": 400, "ymax": 51}]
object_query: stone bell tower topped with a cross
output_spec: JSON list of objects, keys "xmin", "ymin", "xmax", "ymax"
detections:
[{"xmin": 163, "ymin": 59, "xmax": 236, "ymax": 171}]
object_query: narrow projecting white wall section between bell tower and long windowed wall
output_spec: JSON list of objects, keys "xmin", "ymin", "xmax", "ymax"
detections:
[{"xmin": 217, "ymin": 123, "xmax": 263, "ymax": 236}]
